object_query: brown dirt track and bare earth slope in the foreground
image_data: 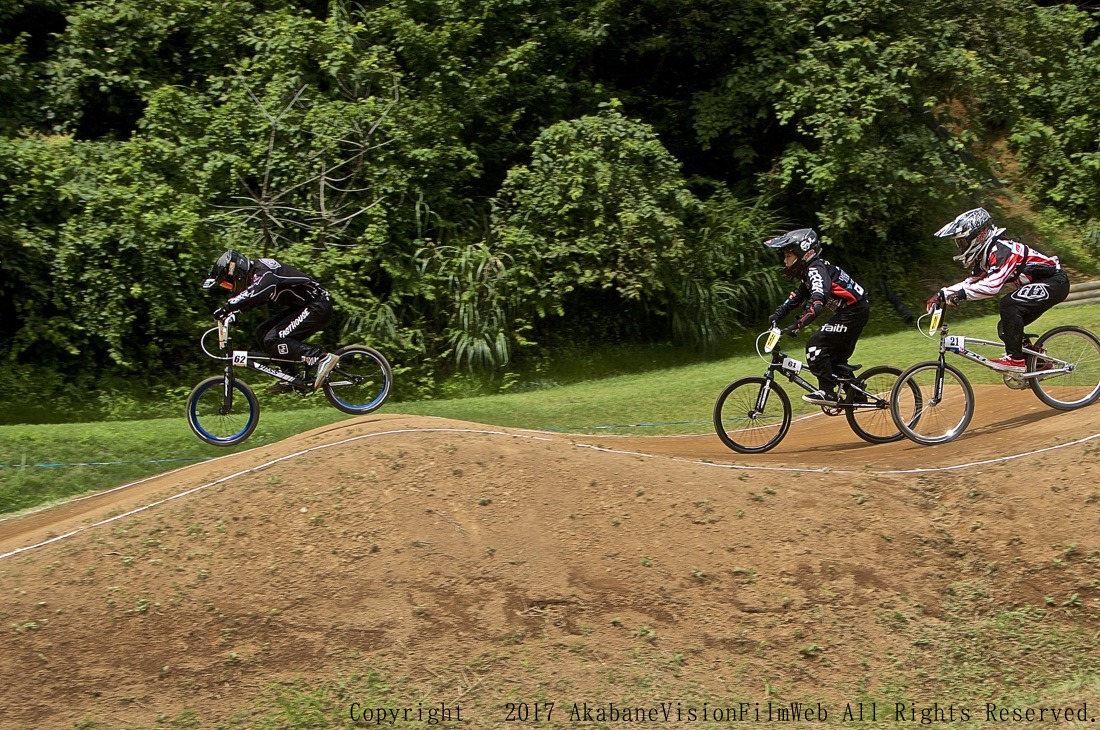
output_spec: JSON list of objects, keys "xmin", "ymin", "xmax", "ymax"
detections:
[{"xmin": 0, "ymin": 389, "xmax": 1100, "ymax": 728}]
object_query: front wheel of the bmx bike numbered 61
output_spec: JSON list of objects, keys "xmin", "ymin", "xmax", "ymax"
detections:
[{"xmin": 714, "ymin": 377, "xmax": 791, "ymax": 454}]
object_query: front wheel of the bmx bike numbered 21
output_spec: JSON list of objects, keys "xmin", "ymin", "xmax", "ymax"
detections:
[{"xmin": 890, "ymin": 362, "xmax": 974, "ymax": 446}]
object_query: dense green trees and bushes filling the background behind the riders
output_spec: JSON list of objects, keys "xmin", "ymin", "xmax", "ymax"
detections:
[{"xmin": 0, "ymin": 0, "xmax": 1100, "ymax": 411}]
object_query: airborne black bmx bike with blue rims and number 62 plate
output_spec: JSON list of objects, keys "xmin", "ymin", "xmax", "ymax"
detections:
[{"xmin": 187, "ymin": 314, "xmax": 394, "ymax": 446}]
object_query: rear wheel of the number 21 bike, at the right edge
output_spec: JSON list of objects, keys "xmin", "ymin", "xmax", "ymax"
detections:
[{"xmin": 1027, "ymin": 324, "xmax": 1100, "ymax": 410}]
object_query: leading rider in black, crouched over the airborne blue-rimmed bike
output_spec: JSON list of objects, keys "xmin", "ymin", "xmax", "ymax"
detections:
[{"xmin": 202, "ymin": 251, "xmax": 339, "ymax": 392}]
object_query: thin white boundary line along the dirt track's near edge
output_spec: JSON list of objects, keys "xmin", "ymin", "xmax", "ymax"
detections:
[{"xmin": 0, "ymin": 429, "xmax": 1100, "ymax": 560}]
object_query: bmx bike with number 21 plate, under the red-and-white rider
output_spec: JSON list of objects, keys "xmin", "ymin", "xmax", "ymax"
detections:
[{"xmin": 890, "ymin": 297, "xmax": 1100, "ymax": 446}]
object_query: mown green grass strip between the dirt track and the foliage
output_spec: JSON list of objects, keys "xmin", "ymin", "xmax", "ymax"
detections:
[{"xmin": 0, "ymin": 305, "xmax": 1100, "ymax": 513}]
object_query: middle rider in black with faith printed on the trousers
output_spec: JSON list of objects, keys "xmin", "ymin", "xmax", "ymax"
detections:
[{"xmin": 765, "ymin": 229, "xmax": 870, "ymax": 406}]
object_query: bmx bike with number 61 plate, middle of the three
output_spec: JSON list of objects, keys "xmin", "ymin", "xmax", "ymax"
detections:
[{"xmin": 714, "ymin": 329, "xmax": 904, "ymax": 454}]
